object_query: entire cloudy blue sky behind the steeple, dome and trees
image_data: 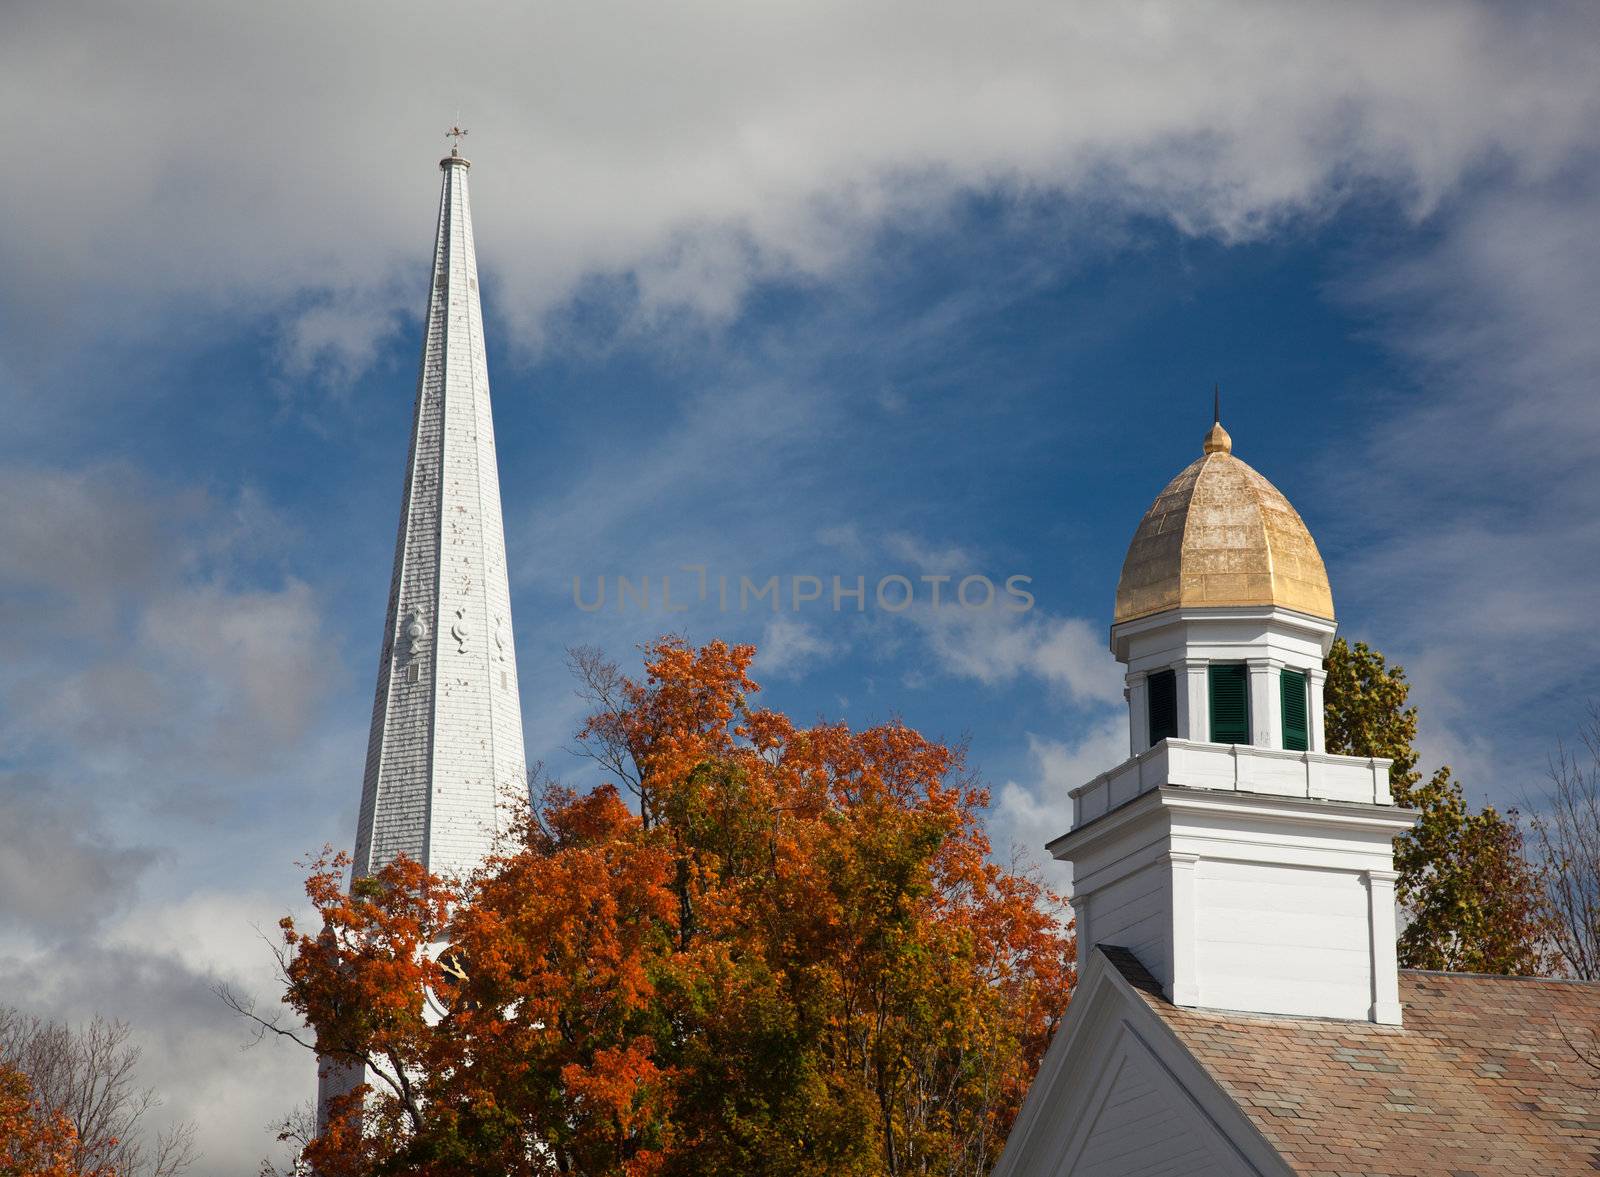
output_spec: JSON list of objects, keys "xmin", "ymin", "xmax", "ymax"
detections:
[{"xmin": 0, "ymin": 3, "xmax": 1600, "ymax": 1172}]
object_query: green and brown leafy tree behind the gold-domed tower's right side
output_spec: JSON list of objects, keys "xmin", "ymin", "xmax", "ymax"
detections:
[{"xmin": 1325, "ymin": 638, "xmax": 1549, "ymax": 976}]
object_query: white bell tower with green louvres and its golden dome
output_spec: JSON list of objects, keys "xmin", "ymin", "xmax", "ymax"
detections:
[{"xmin": 1050, "ymin": 422, "xmax": 1413, "ymax": 1025}]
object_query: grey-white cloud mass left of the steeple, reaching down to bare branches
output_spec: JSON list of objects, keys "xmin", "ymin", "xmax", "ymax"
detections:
[{"xmin": 0, "ymin": 465, "xmax": 347, "ymax": 1172}]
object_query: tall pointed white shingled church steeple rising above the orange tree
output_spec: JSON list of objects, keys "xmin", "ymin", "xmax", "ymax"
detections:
[{"xmin": 355, "ymin": 133, "xmax": 526, "ymax": 875}]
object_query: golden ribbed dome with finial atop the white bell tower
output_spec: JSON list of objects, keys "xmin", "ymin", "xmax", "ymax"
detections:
[{"xmin": 1115, "ymin": 424, "xmax": 1333, "ymax": 622}]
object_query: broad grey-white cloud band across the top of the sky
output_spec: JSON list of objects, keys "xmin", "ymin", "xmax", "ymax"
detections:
[{"xmin": 0, "ymin": 0, "xmax": 1600, "ymax": 388}]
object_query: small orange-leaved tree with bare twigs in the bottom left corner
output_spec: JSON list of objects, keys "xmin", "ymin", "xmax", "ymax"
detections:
[{"xmin": 0, "ymin": 1007, "xmax": 195, "ymax": 1177}]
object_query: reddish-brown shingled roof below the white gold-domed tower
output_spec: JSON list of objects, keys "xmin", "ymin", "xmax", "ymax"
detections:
[{"xmin": 1101, "ymin": 945, "xmax": 1600, "ymax": 1177}]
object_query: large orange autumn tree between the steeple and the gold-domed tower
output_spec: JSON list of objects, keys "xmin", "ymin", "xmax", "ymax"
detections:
[{"xmin": 259, "ymin": 640, "xmax": 1074, "ymax": 1177}]
